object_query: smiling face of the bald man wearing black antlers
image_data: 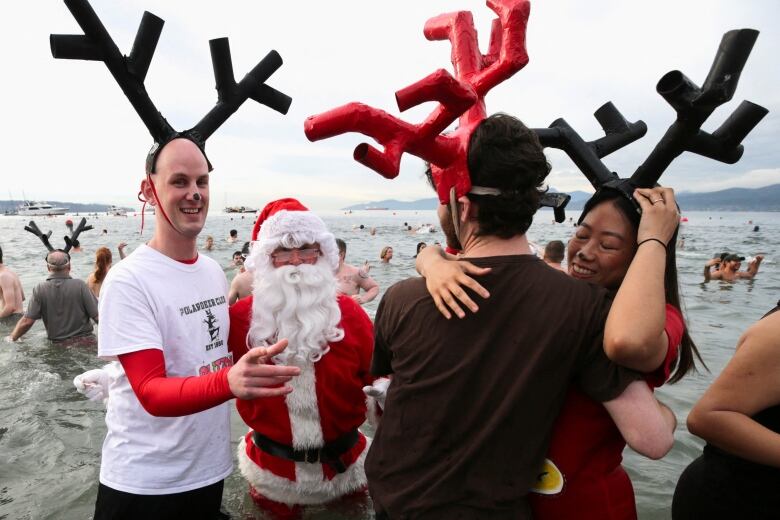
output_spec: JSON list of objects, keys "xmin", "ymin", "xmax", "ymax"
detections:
[{"xmin": 144, "ymin": 139, "xmax": 209, "ymax": 239}]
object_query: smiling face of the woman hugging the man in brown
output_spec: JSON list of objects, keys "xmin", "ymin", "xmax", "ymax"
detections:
[{"xmin": 567, "ymin": 201, "xmax": 636, "ymax": 289}]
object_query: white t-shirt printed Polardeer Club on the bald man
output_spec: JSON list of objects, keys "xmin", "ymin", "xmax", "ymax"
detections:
[{"xmin": 98, "ymin": 245, "xmax": 233, "ymax": 495}]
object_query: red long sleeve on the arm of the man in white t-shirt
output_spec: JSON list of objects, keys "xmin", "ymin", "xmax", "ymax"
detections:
[{"xmin": 119, "ymin": 349, "xmax": 234, "ymax": 417}]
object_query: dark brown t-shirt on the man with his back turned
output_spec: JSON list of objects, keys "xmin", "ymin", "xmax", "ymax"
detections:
[{"xmin": 365, "ymin": 255, "xmax": 640, "ymax": 520}]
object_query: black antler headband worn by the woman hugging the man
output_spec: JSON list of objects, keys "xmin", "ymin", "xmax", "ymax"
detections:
[{"xmin": 534, "ymin": 29, "xmax": 768, "ymax": 219}]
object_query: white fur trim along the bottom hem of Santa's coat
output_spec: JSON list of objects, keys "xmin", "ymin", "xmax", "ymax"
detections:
[{"xmin": 238, "ymin": 437, "xmax": 371, "ymax": 506}]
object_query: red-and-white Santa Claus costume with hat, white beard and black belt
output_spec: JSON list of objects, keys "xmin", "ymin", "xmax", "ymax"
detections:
[{"xmin": 228, "ymin": 199, "xmax": 374, "ymax": 514}]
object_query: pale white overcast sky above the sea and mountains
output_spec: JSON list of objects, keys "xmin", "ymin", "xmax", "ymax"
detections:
[{"xmin": 0, "ymin": 0, "xmax": 780, "ymax": 209}]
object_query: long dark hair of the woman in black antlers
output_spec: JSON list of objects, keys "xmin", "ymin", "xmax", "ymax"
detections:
[{"xmin": 577, "ymin": 189, "xmax": 709, "ymax": 383}]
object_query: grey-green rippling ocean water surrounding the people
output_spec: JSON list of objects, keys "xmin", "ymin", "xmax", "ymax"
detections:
[{"xmin": 0, "ymin": 211, "xmax": 780, "ymax": 520}]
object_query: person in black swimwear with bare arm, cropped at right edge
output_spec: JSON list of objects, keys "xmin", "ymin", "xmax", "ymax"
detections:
[{"xmin": 672, "ymin": 302, "xmax": 780, "ymax": 520}]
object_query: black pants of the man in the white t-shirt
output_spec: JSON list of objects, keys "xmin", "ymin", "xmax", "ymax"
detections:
[{"xmin": 94, "ymin": 480, "xmax": 230, "ymax": 520}]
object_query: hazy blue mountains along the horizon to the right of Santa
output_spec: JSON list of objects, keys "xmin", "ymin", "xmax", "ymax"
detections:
[{"xmin": 342, "ymin": 184, "xmax": 780, "ymax": 211}]
